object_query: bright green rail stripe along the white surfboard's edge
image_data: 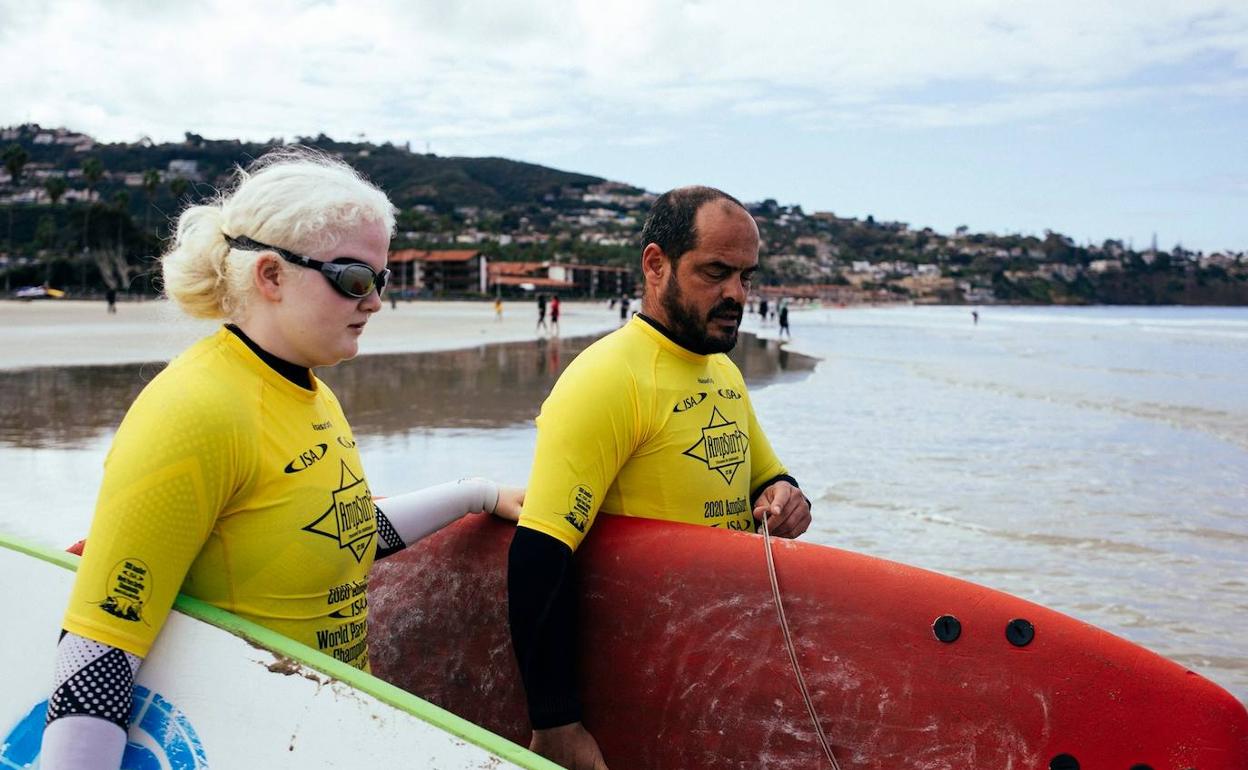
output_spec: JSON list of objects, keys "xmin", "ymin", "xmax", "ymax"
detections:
[{"xmin": 0, "ymin": 532, "xmax": 559, "ymax": 770}]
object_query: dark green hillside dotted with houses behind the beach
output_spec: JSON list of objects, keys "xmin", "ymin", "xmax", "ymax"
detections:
[{"xmin": 0, "ymin": 125, "xmax": 1248, "ymax": 305}]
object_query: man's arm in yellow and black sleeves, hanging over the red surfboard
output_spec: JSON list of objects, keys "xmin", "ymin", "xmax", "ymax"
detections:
[{"xmin": 508, "ymin": 344, "xmax": 644, "ymax": 770}]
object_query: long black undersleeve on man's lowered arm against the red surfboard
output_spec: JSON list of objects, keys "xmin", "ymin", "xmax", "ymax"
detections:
[{"xmin": 507, "ymin": 527, "xmax": 580, "ymax": 730}]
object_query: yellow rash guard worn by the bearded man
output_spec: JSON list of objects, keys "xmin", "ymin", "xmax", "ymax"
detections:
[{"xmin": 520, "ymin": 317, "xmax": 786, "ymax": 550}]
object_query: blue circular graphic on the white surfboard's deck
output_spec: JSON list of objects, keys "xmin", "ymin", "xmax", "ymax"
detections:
[{"xmin": 0, "ymin": 684, "xmax": 208, "ymax": 770}]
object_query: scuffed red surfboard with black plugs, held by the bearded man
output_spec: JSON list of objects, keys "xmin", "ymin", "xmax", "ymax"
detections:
[{"xmin": 369, "ymin": 515, "xmax": 1248, "ymax": 770}]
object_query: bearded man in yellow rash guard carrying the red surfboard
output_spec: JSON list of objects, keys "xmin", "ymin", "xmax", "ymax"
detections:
[{"xmin": 508, "ymin": 187, "xmax": 810, "ymax": 770}]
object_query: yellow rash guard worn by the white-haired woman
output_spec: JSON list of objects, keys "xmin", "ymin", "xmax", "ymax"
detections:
[{"xmin": 64, "ymin": 328, "xmax": 377, "ymax": 669}]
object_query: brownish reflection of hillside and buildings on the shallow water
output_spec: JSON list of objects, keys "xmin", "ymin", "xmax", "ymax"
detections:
[{"xmin": 0, "ymin": 334, "xmax": 815, "ymax": 449}]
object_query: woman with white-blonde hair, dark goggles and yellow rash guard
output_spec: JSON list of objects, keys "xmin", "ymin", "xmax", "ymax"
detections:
[{"xmin": 40, "ymin": 149, "xmax": 523, "ymax": 770}]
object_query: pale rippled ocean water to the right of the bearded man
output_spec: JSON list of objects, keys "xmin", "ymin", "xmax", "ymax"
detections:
[{"xmin": 755, "ymin": 307, "xmax": 1248, "ymax": 701}]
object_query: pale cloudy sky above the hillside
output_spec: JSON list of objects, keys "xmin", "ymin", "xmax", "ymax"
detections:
[{"xmin": 0, "ymin": 0, "xmax": 1248, "ymax": 145}]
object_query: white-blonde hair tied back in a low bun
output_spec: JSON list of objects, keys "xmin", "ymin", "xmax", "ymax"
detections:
[{"xmin": 161, "ymin": 146, "xmax": 394, "ymax": 319}]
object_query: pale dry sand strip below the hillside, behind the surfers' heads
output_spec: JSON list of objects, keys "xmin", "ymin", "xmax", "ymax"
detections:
[{"xmin": 0, "ymin": 300, "xmax": 619, "ymax": 369}]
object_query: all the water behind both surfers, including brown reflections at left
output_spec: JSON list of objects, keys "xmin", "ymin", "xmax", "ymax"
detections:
[{"xmin": 0, "ymin": 307, "xmax": 1248, "ymax": 701}]
